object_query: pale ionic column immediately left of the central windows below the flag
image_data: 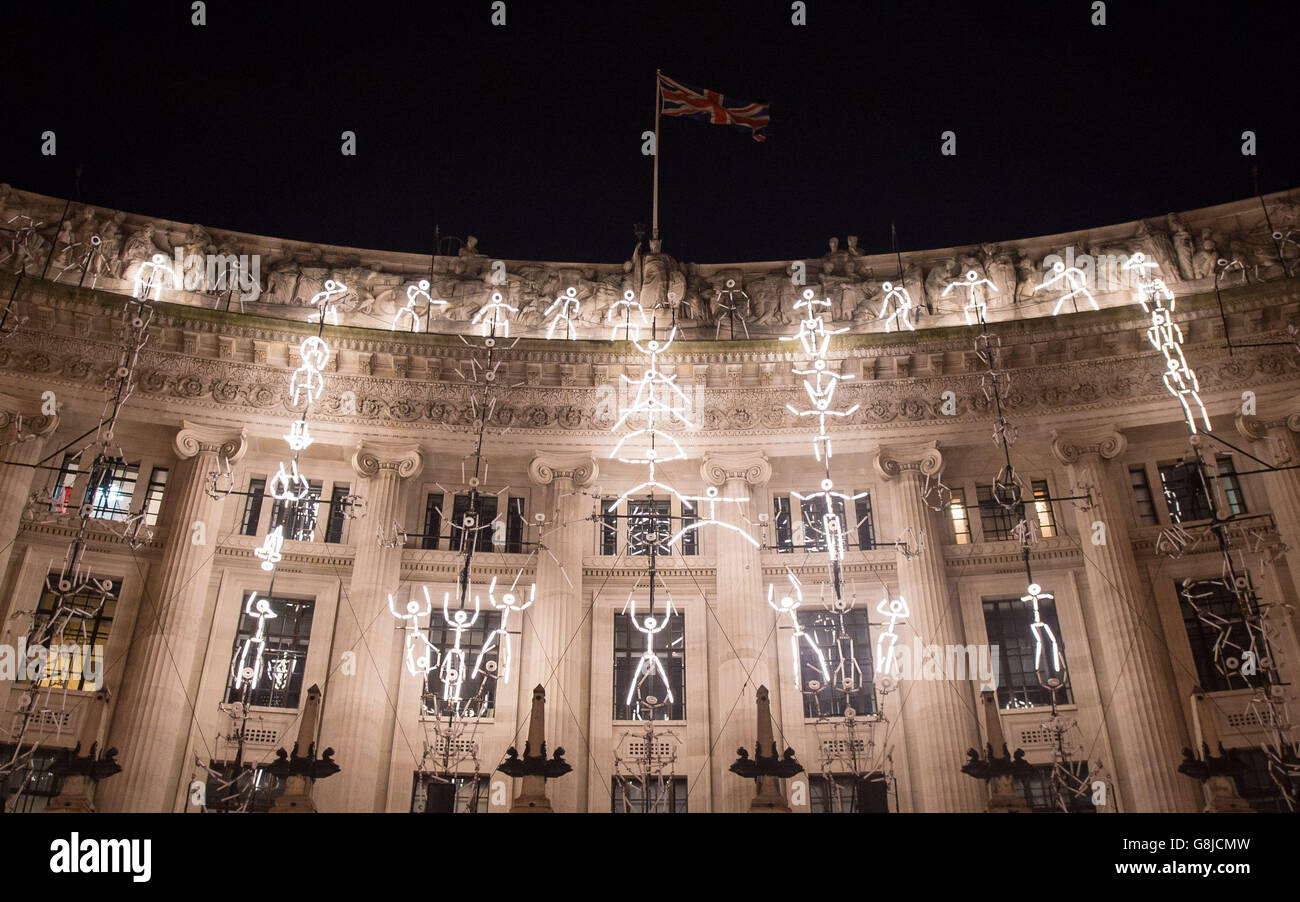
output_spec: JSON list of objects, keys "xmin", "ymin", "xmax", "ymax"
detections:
[{"xmin": 511, "ymin": 452, "xmax": 595, "ymax": 812}]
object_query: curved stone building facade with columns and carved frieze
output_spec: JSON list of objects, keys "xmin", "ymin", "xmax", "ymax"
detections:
[{"xmin": 0, "ymin": 188, "xmax": 1300, "ymax": 812}]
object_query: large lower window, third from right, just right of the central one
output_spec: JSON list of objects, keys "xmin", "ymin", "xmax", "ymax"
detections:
[{"xmin": 797, "ymin": 607, "xmax": 875, "ymax": 717}]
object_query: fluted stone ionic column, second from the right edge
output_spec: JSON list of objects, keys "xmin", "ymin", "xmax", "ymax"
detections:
[{"xmin": 1052, "ymin": 426, "xmax": 1197, "ymax": 811}]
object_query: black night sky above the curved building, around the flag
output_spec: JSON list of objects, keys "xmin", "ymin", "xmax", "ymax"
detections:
[{"xmin": 0, "ymin": 0, "xmax": 1300, "ymax": 261}]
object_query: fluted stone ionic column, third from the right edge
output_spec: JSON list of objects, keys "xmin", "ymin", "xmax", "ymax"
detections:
[{"xmin": 875, "ymin": 442, "xmax": 987, "ymax": 812}]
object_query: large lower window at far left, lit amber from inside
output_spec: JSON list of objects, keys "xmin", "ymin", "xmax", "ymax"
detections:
[{"xmin": 29, "ymin": 571, "xmax": 122, "ymax": 693}]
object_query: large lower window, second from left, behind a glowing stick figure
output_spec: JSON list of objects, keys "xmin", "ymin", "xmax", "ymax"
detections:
[{"xmin": 225, "ymin": 597, "xmax": 316, "ymax": 712}]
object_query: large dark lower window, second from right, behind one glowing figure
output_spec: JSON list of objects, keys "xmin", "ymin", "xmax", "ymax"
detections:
[{"xmin": 984, "ymin": 598, "xmax": 1073, "ymax": 708}]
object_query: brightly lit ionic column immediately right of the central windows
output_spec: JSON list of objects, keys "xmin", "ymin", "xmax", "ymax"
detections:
[{"xmin": 702, "ymin": 452, "xmax": 784, "ymax": 812}]
